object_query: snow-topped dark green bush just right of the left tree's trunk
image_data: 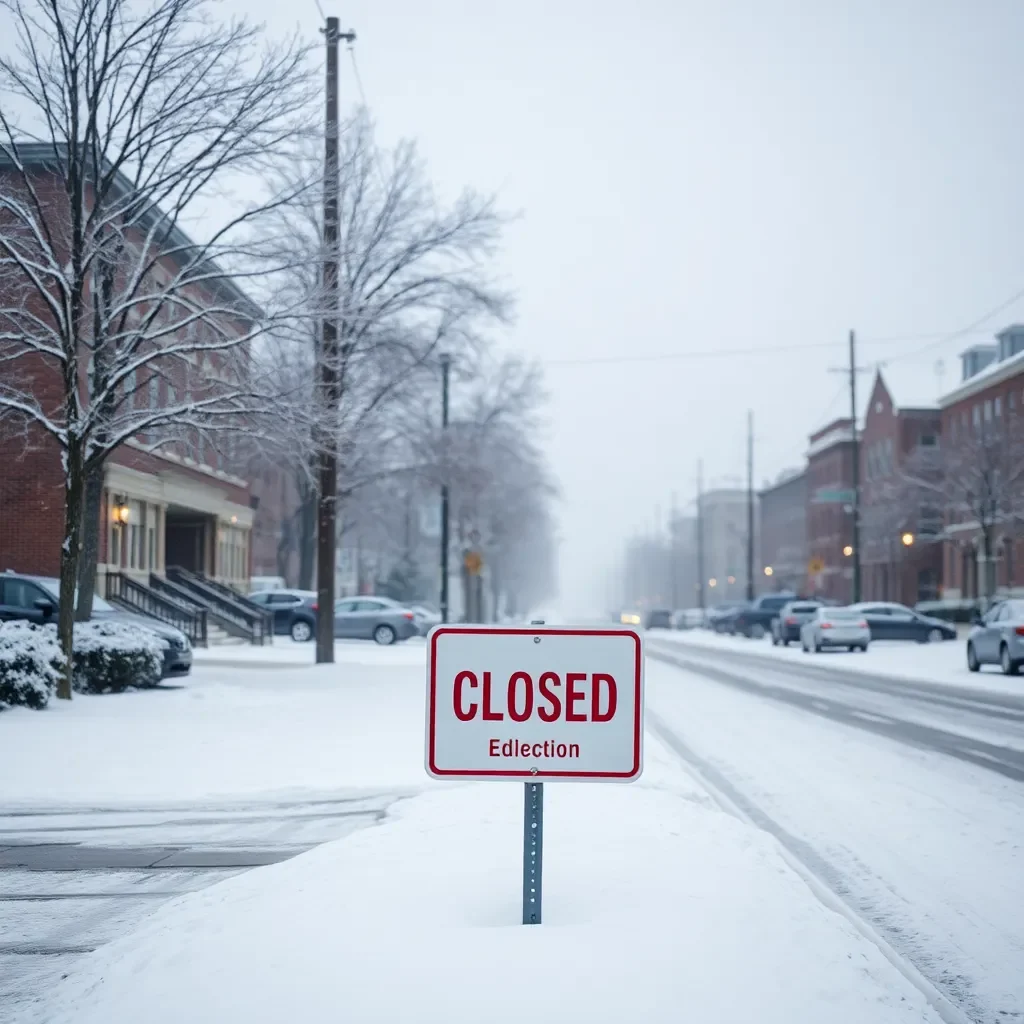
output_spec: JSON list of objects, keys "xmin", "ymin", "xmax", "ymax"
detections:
[{"xmin": 72, "ymin": 620, "xmax": 167, "ymax": 693}]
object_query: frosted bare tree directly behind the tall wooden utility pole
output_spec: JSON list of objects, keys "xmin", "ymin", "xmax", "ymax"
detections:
[{"xmin": 262, "ymin": 116, "xmax": 510, "ymax": 660}]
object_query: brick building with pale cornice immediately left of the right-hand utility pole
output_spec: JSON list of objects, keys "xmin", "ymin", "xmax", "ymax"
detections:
[{"xmin": 807, "ymin": 418, "xmax": 854, "ymax": 604}]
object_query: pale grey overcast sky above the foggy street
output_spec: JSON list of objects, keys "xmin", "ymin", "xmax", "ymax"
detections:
[{"xmin": 18, "ymin": 0, "xmax": 1024, "ymax": 613}]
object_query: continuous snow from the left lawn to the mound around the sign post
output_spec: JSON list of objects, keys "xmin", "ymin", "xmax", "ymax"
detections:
[{"xmin": 0, "ymin": 644, "xmax": 966, "ymax": 1024}]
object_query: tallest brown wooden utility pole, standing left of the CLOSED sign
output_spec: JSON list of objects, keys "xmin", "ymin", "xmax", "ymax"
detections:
[{"xmin": 316, "ymin": 17, "xmax": 355, "ymax": 665}]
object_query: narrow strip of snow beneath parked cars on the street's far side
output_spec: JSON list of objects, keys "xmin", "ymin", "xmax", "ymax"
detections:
[{"xmin": 647, "ymin": 630, "xmax": 1024, "ymax": 696}]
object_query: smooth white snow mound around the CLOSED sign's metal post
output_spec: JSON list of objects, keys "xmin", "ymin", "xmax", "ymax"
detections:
[{"xmin": 18, "ymin": 783, "xmax": 937, "ymax": 1024}]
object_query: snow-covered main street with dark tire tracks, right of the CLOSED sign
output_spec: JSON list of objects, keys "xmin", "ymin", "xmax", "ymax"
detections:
[{"xmin": 647, "ymin": 641, "xmax": 1024, "ymax": 1022}]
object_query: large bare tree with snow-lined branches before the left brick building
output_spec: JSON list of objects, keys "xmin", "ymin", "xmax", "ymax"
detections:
[{"xmin": 0, "ymin": 0, "xmax": 311, "ymax": 697}]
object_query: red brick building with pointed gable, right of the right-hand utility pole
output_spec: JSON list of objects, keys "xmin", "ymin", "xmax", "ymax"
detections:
[{"xmin": 860, "ymin": 371, "xmax": 942, "ymax": 605}]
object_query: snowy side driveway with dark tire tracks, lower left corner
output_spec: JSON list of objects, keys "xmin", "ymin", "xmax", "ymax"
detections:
[{"xmin": 0, "ymin": 796, "xmax": 393, "ymax": 1024}]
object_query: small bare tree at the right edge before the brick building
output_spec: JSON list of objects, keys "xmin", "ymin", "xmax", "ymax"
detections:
[{"xmin": 904, "ymin": 402, "xmax": 1024, "ymax": 599}]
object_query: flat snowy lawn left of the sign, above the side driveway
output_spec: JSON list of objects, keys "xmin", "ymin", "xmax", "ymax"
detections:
[{"xmin": 0, "ymin": 643, "xmax": 425, "ymax": 810}]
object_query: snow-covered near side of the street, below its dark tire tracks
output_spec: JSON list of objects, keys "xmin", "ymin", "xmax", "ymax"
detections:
[{"xmin": 647, "ymin": 655, "xmax": 1024, "ymax": 1024}]
